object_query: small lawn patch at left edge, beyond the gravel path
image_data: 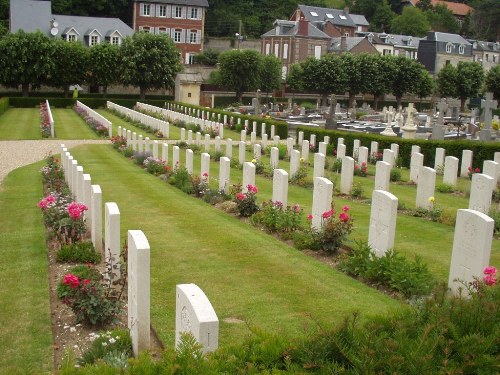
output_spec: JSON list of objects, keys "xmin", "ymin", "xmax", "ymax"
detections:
[{"xmin": 0, "ymin": 108, "xmax": 42, "ymax": 140}]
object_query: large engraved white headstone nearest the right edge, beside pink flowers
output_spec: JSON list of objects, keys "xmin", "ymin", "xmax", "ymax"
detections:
[{"xmin": 448, "ymin": 210, "xmax": 495, "ymax": 294}]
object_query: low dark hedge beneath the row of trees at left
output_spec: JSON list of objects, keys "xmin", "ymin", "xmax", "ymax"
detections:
[{"xmin": 10, "ymin": 97, "xmax": 165, "ymax": 108}]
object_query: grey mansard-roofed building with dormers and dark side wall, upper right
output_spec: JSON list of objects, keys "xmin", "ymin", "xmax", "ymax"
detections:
[{"xmin": 417, "ymin": 31, "xmax": 473, "ymax": 74}]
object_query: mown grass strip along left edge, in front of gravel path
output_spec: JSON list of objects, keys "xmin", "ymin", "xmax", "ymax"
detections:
[{"xmin": 0, "ymin": 163, "xmax": 53, "ymax": 374}]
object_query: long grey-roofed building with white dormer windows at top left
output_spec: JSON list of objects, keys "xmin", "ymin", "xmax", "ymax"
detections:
[{"xmin": 10, "ymin": 0, "xmax": 134, "ymax": 47}]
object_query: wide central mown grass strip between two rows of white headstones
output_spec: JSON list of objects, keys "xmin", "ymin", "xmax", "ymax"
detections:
[{"xmin": 72, "ymin": 146, "xmax": 401, "ymax": 352}]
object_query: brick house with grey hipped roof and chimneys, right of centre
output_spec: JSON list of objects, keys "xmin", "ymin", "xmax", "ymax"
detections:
[{"xmin": 261, "ymin": 18, "xmax": 331, "ymax": 78}]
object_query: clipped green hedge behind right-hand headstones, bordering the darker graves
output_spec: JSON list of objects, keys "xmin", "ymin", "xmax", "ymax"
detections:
[{"xmin": 297, "ymin": 127, "xmax": 500, "ymax": 169}]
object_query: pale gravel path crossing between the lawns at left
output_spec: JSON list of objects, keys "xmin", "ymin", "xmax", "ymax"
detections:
[{"xmin": 0, "ymin": 139, "xmax": 109, "ymax": 185}]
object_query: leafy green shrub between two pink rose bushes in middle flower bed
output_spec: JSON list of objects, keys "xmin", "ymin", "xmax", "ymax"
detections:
[{"xmin": 252, "ymin": 201, "xmax": 302, "ymax": 233}]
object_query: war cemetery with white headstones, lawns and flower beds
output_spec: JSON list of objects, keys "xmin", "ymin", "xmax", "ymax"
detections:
[{"xmin": 0, "ymin": 98, "xmax": 500, "ymax": 374}]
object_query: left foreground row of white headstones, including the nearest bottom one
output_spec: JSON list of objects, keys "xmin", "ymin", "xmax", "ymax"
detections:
[{"xmin": 61, "ymin": 144, "xmax": 219, "ymax": 357}]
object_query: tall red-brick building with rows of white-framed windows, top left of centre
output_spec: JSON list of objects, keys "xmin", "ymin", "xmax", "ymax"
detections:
[{"xmin": 133, "ymin": 0, "xmax": 208, "ymax": 64}]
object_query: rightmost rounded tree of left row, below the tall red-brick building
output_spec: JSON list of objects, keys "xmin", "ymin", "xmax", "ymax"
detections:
[{"xmin": 121, "ymin": 32, "xmax": 182, "ymax": 99}]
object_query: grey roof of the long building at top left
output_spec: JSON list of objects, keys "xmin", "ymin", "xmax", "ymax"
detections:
[{"xmin": 10, "ymin": 0, "xmax": 134, "ymax": 37}]
